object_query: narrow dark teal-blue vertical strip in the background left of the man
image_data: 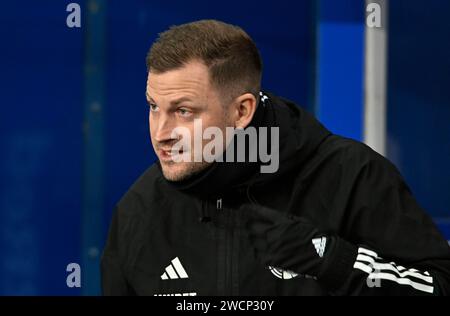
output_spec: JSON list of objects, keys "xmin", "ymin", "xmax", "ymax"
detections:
[{"xmin": 81, "ymin": 0, "xmax": 108, "ymax": 295}]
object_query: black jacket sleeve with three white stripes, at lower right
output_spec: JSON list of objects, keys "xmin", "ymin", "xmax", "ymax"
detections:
[{"xmin": 318, "ymin": 157, "xmax": 450, "ymax": 295}]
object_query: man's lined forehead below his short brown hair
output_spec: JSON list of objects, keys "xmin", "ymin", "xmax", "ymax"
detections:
[{"xmin": 147, "ymin": 62, "xmax": 210, "ymax": 98}]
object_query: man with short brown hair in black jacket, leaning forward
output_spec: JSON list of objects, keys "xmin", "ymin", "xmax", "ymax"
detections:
[{"xmin": 102, "ymin": 20, "xmax": 450, "ymax": 295}]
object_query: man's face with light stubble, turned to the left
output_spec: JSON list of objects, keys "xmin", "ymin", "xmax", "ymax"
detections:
[{"xmin": 146, "ymin": 61, "xmax": 234, "ymax": 181}]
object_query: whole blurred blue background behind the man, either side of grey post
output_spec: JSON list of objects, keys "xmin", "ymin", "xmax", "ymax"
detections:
[{"xmin": 0, "ymin": 0, "xmax": 450, "ymax": 295}]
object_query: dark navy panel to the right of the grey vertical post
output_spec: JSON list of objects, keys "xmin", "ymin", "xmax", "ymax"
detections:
[{"xmin": 387, "ymin": 0, "xmax": 450, "ymax": 222}]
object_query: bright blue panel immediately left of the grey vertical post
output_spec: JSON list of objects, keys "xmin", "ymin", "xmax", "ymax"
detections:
[{"xmin": 315, "ymin": 0, "xmax": 365, "ymax": 140}]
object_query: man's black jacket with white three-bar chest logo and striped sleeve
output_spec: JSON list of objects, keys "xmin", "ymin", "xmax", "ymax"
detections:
[{"xmin": 101, "ymin": 94, "xmax": 450, "ymax": 295}]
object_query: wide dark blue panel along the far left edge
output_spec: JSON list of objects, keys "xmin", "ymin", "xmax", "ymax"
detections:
[{"xmin": 0, "ymin": 1, "xmax": 83, "ymax": 295}]
